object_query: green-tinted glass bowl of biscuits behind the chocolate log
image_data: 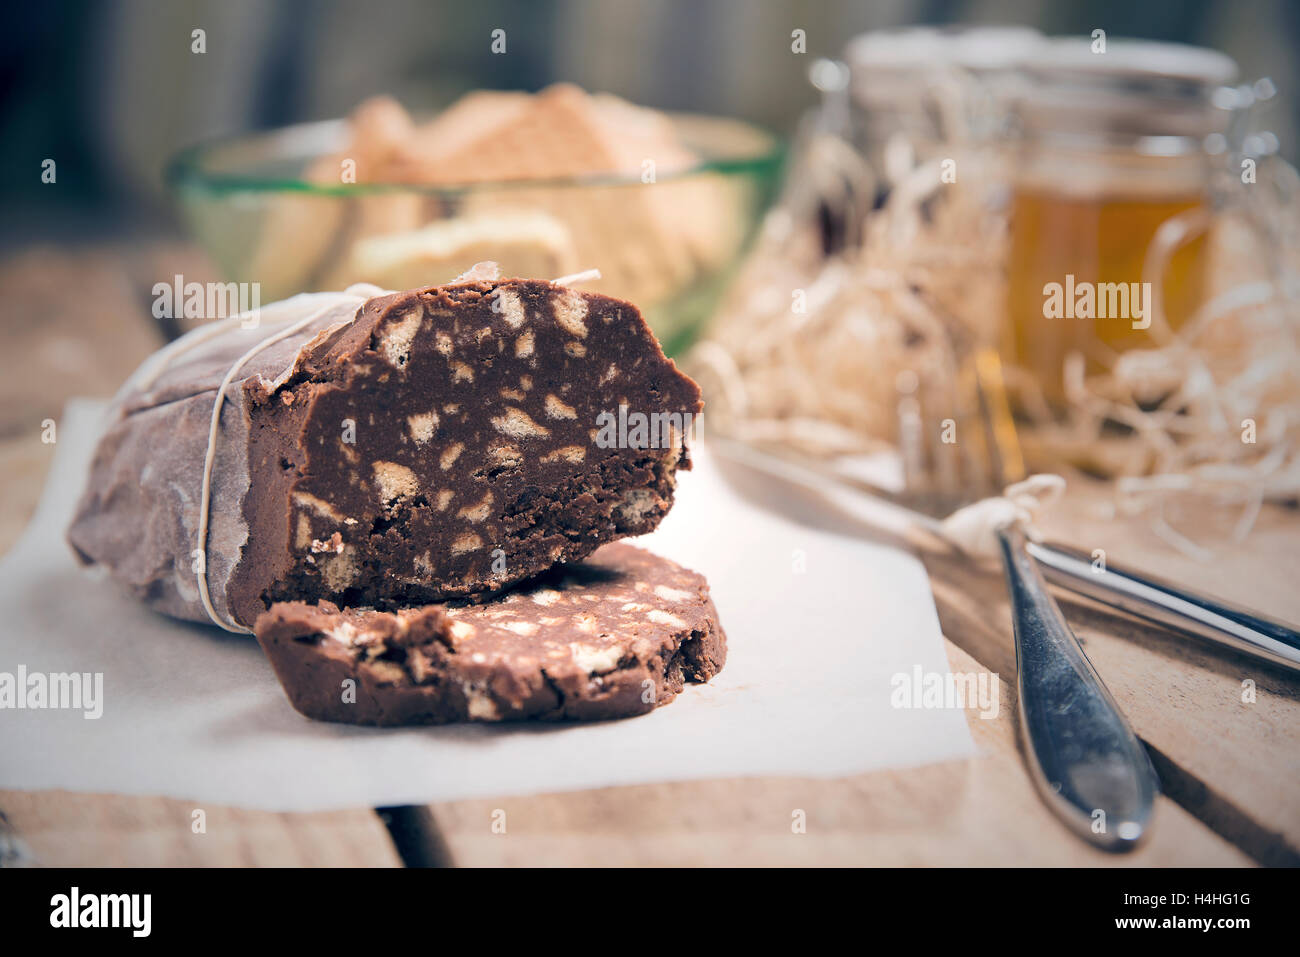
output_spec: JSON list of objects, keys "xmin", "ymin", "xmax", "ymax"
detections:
[{"xmin": 166, "ymin": 114, "xmax": 784, "ymax": 354}]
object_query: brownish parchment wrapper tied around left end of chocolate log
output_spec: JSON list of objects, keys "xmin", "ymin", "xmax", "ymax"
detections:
[{"xmin": 68, "ymin": 286, "xmax": 384, "ymax": 622}]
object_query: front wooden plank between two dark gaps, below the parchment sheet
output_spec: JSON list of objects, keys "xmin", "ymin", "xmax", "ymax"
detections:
[{"xmin": 434, "ymin": 644, "xmax": 1251, "ymax": 866}]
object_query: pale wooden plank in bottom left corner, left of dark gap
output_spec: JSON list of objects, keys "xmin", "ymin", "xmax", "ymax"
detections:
[{"xmin": 0, "ymin": 791, "xmax": 402, "ymax": 867}]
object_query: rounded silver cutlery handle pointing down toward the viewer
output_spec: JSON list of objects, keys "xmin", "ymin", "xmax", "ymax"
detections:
[{"xmin": 997, "ymin": 528, "xmax": 1160, "ymax": 850}]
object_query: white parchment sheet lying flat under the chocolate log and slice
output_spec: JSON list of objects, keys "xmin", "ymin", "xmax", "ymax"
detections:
[{"xmin": 0, "ymin": 400, "xmax": 975, "ymax": 810}]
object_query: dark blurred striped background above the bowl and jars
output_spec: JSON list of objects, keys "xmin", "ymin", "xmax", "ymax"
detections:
[{"xmin": 0, "ymin": 0, "xmax": 1300, "ymax": 247}]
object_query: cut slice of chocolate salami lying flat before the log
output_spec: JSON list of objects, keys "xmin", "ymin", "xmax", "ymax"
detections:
[{"xmin": 256, "ymin": 544, "xmax": 727, "ymax": 726}]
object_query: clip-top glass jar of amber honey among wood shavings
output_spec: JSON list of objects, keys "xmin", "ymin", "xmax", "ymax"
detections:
[{"xmin": 1001, "ymin": 36, "xmax": 1236, "ymax": 408}]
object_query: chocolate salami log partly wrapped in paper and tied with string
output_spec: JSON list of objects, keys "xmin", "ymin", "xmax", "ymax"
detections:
[{"xmin": 69, "ymin": 280, "xmax": 701, "ymax": 631}]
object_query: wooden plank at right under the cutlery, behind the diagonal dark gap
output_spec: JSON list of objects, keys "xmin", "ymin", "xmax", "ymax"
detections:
[{"xmin": 923, "ymin": 489, "xmax": 1300, "ymax": 865}]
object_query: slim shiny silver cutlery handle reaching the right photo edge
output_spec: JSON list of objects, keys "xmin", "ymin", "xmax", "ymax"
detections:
[{"xmin": 1026, "ymin": 542, "xmax": 1300, "ymax": 672}]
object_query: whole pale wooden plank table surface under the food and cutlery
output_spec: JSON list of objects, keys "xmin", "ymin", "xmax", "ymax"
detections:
[{"xmin": 0, "ymin": 243, "xmax": 1300, "ymax": 866}]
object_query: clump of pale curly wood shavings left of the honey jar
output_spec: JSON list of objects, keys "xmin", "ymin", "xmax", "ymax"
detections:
[{"xmin": 689, "ymin": 125, "xmax": 1005, "ymax": 455}]
